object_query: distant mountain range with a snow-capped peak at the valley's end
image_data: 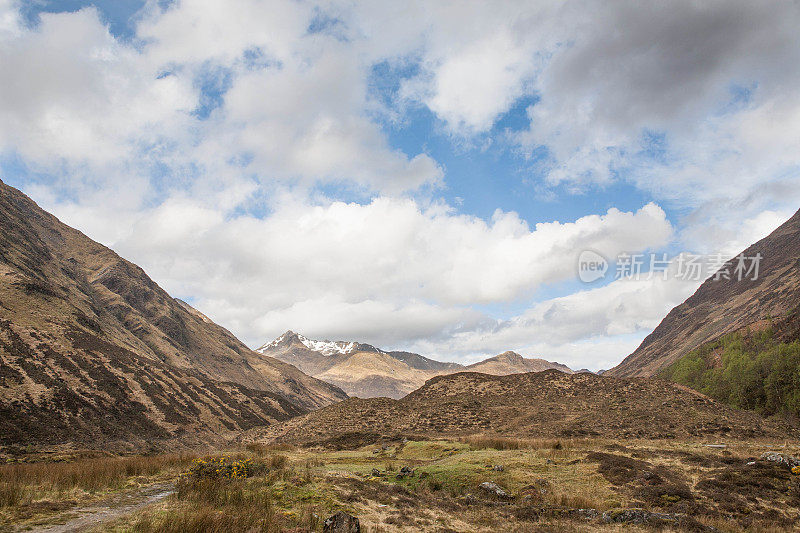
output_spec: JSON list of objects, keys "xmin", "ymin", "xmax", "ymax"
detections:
[{"xmin": 256, "ymin": 331, "xmax": 572, "ymax": 399}]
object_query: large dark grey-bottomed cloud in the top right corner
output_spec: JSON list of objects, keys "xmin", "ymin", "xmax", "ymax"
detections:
[{"xmin": 519, "ymin": 1, "xmax": 800, "ymax": 213}]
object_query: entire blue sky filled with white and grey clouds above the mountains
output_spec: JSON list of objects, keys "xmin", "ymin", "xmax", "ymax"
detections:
[{"xmin": 0, "ymin": 0, "xmax": 800, "ymax": 370}]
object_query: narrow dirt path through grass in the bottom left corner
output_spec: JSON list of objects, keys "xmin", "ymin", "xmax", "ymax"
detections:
[{"xmin": 23, "ymin": 483, "xmax": 175, "ymax": 533}]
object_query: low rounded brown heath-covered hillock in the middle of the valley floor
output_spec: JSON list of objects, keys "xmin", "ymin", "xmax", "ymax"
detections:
[{"xmin": 241, "ymin": 370, "xmax": 797, "ymax": 444}]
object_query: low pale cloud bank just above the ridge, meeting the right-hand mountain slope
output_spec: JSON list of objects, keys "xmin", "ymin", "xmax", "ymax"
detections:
[{"xmin": 404, "ymin": 262, "xmax": 702, "ymax": 370}]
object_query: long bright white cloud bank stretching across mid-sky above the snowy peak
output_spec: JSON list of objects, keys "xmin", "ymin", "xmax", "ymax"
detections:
[{"xmin": 40, "ymin": 189, "xmax": 673, "ymax": 353}]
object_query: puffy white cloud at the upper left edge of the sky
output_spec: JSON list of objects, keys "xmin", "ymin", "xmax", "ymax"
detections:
[{"xmin": 0, "ymin": 8, "xmax": 196, "ymax": 167}]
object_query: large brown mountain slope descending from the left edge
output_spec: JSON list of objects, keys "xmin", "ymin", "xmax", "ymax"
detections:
[{"xmin": 0, "ymin": 181, "xmax": 346, "ymax": 448}]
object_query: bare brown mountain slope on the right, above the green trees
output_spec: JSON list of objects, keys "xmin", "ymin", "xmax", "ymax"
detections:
[{"xmin": 606, "ymin": 206, "xmax": 800, "ymax": 377}]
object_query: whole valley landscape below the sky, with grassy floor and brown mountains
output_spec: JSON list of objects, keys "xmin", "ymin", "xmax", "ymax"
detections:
[{"xmin": 0, "ymin": 178, "xmax": 800, "ymax": 533}]
